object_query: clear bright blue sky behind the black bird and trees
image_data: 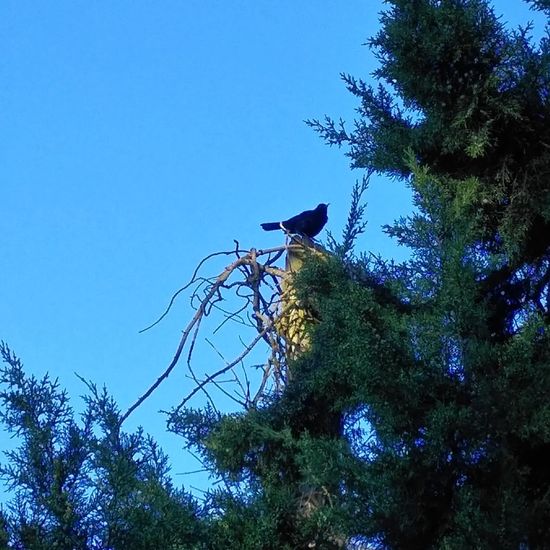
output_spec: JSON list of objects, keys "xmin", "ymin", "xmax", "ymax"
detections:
[{"xmin": 0, "ymin": 0, "xmax": 542, "ymax": 500}]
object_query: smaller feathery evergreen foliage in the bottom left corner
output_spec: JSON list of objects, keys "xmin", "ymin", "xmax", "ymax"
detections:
[{"xmin": 0, "ymin": 344, "xmax": 201, "ymax": 550}]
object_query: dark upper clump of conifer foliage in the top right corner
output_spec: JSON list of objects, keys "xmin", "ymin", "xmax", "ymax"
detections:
[{"xmin": 310, "ymin": 0, "xmax": 550, "ymax": 261}]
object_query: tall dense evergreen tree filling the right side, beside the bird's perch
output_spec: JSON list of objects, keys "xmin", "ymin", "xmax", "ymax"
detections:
[{"xmin": 175, "ymin": 0, "xmax": 550, "ymax": 549}]
